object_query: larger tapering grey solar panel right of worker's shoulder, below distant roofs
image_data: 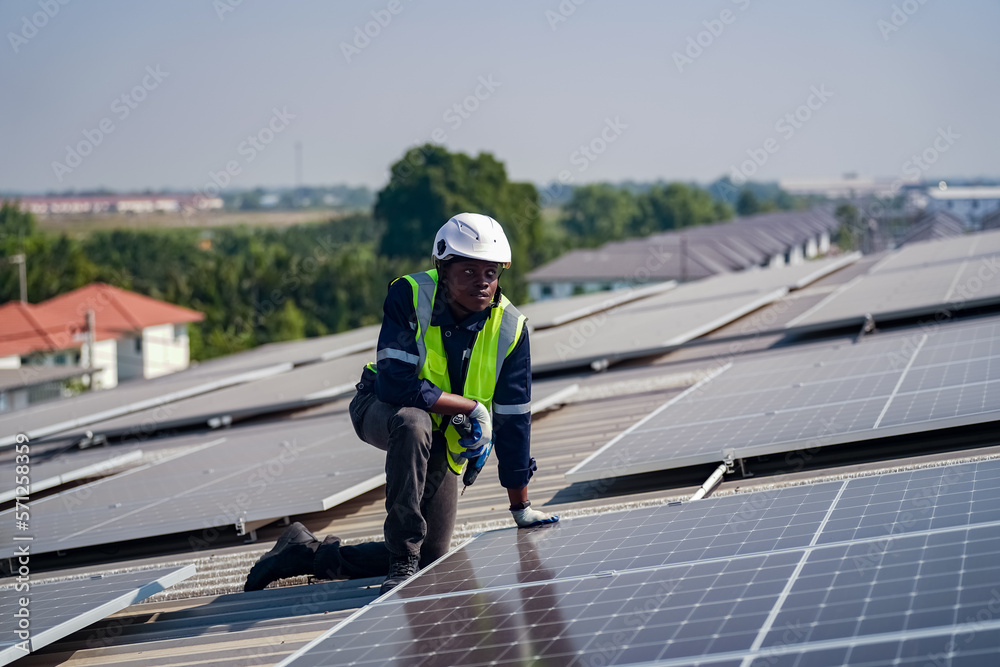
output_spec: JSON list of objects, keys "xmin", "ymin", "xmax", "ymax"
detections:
[{"xmin": 531, "ymin": 255, "xmax": 858, "ymax": 373}]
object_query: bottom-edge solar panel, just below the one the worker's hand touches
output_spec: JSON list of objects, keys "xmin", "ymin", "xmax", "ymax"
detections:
[{"xmin": 295, "ymin": 554, "xmax": 797, "ymax": 666}]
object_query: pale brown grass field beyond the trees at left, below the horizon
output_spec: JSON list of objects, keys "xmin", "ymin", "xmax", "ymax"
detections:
[{"xmin": 38, "ymin": 209, "xmax": 358, "ymax": 236}]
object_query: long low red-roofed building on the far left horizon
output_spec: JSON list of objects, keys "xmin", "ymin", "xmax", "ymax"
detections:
[{"xmin": 12, "ymin": 194, "xmax": 222, "ymax": 216}]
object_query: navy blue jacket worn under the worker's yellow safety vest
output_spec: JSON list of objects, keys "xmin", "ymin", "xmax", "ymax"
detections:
[{"xmin": 375, "ymin": 280, "xmax": 535, "ymax": 489}]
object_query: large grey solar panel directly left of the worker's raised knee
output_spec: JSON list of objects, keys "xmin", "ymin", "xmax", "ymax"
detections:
[{"xmin": 0, "ymin": 414, "xmax": 385, "ymax": 557}]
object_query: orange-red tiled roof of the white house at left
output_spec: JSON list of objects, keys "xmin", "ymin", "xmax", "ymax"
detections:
[{"xmin": 0, "ymin": 283, "xmax": 205, "ymax": 357}]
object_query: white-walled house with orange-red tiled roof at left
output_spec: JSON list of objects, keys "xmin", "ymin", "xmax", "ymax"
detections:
[{"xmin": 0, "ymin": 283, "xmax": 204, "ymax": 412}]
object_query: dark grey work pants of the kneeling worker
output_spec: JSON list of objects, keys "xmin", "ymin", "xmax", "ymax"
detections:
[{"xmin": 341, "ymin": 393, "xmax": 458, "ymax": 571}]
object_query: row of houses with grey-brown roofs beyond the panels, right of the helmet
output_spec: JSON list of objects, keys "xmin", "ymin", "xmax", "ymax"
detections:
[{"xmin": 527, "ymin": 209, "xmax": 839, "ymax": 301}]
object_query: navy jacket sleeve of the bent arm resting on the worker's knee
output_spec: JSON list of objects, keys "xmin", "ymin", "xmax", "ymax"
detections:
[{"xmin": 375, "ymin": 278, "xmax": 442, "ymax": 410}]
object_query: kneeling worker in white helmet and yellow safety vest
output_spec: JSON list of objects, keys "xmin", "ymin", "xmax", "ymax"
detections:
[{"xmin": 244, "ymin": 213, "xmax": 559, "ymax": 593}]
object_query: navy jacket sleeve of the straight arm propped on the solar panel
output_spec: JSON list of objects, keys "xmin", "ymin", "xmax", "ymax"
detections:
[{"xmin": 493, "ymin": 327, "xmax": 535, "ymax": 489}]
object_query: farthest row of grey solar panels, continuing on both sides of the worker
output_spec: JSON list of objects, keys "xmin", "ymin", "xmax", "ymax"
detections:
[{"xmin": 9, "ymin": 232, "xmax": 1000, "ymax": 454}]
